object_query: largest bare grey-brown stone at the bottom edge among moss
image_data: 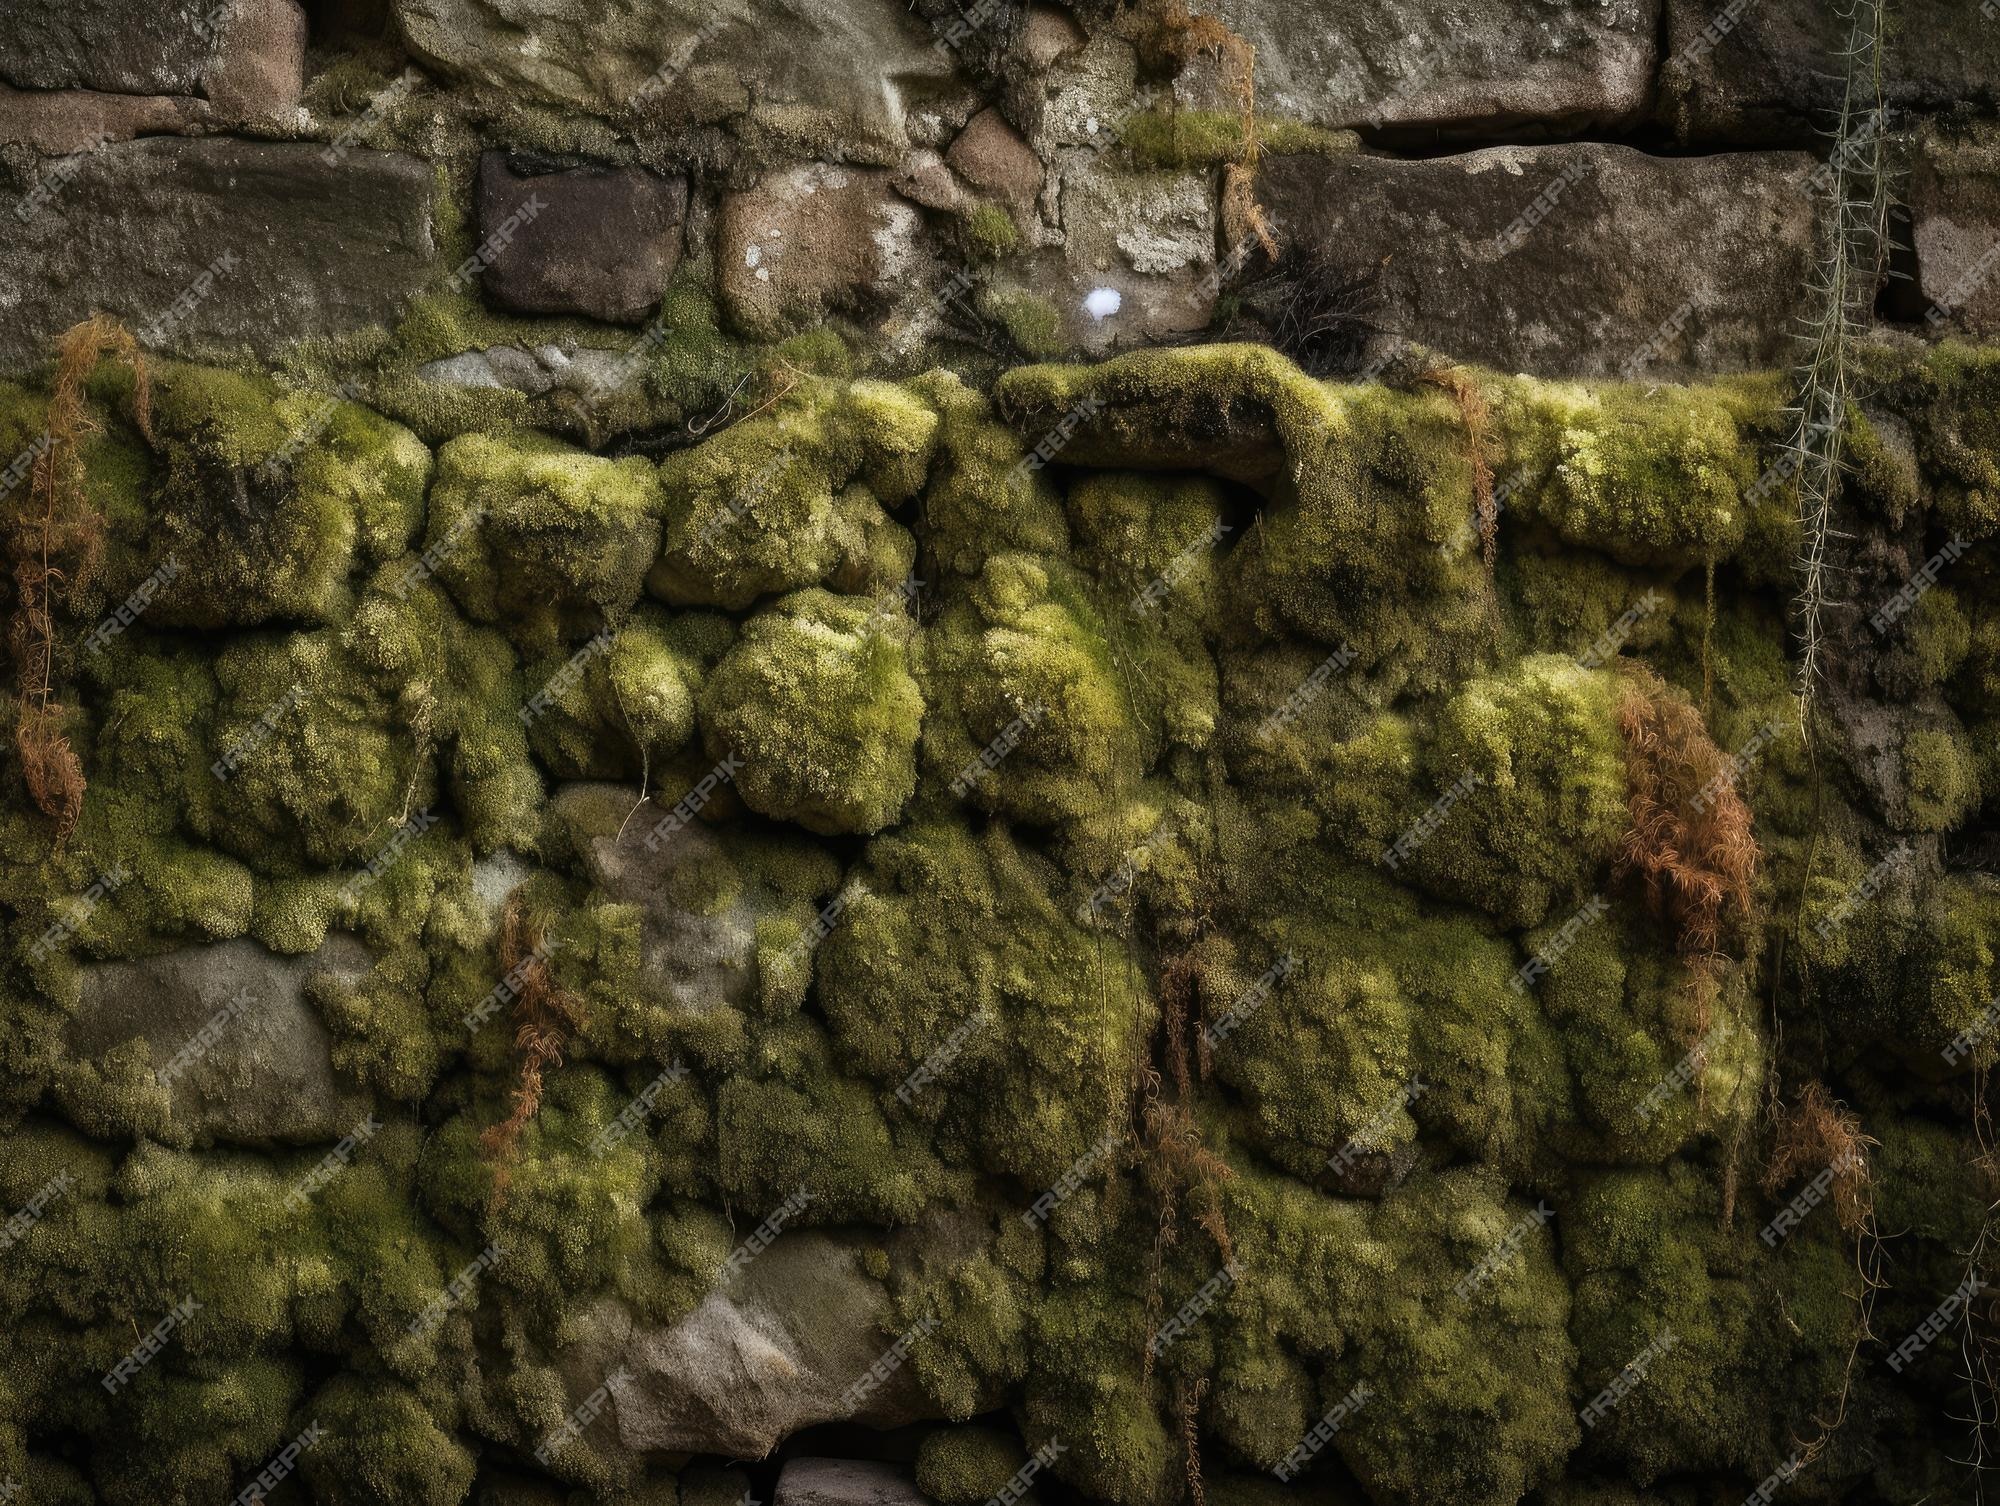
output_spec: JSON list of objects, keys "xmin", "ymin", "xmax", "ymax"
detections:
[{"xmin": 562, "ymin": 1232, "xmax": 936, "ymax": 1458}]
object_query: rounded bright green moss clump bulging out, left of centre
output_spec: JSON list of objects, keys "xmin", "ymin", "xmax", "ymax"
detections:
[{"xmin": 702, "ymin": 590, "xmax": 924, "ymax": 832}]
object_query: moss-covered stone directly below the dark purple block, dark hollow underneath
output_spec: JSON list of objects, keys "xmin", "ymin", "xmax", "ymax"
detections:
[{"xmin": 428, "ymin": 434, "xmax": 664, "ymax": 648}]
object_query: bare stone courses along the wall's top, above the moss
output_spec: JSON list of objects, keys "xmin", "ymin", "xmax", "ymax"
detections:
[{"xmin": 0, "ymin": 0, "xmax": 2000, "ymax": 400}]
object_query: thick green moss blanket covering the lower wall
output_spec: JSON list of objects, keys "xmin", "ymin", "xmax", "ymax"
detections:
[{"xmin": 11, "ymin": 346, "xmax": 2000, "ymax": 1506}]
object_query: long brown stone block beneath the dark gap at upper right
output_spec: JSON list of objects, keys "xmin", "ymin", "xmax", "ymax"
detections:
[{"xmin": 1258, "ymin": 144, "xmax": 1812, "ymax": 376}]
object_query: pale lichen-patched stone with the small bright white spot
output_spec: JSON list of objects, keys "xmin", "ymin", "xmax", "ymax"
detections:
[{"xmin": 1056, "ymin": 156, "xmax": 1216, "ymax": 352}]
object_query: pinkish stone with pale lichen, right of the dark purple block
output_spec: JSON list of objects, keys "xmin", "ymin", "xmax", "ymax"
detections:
[{"xmin": 716, "ymin": 162, "xmax": 924, "ymax": 338}]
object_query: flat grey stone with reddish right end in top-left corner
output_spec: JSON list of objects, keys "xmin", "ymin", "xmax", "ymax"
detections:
[{"xmin": 0, "ymin": 0, "xmax": 306, "ymax": 110}]
